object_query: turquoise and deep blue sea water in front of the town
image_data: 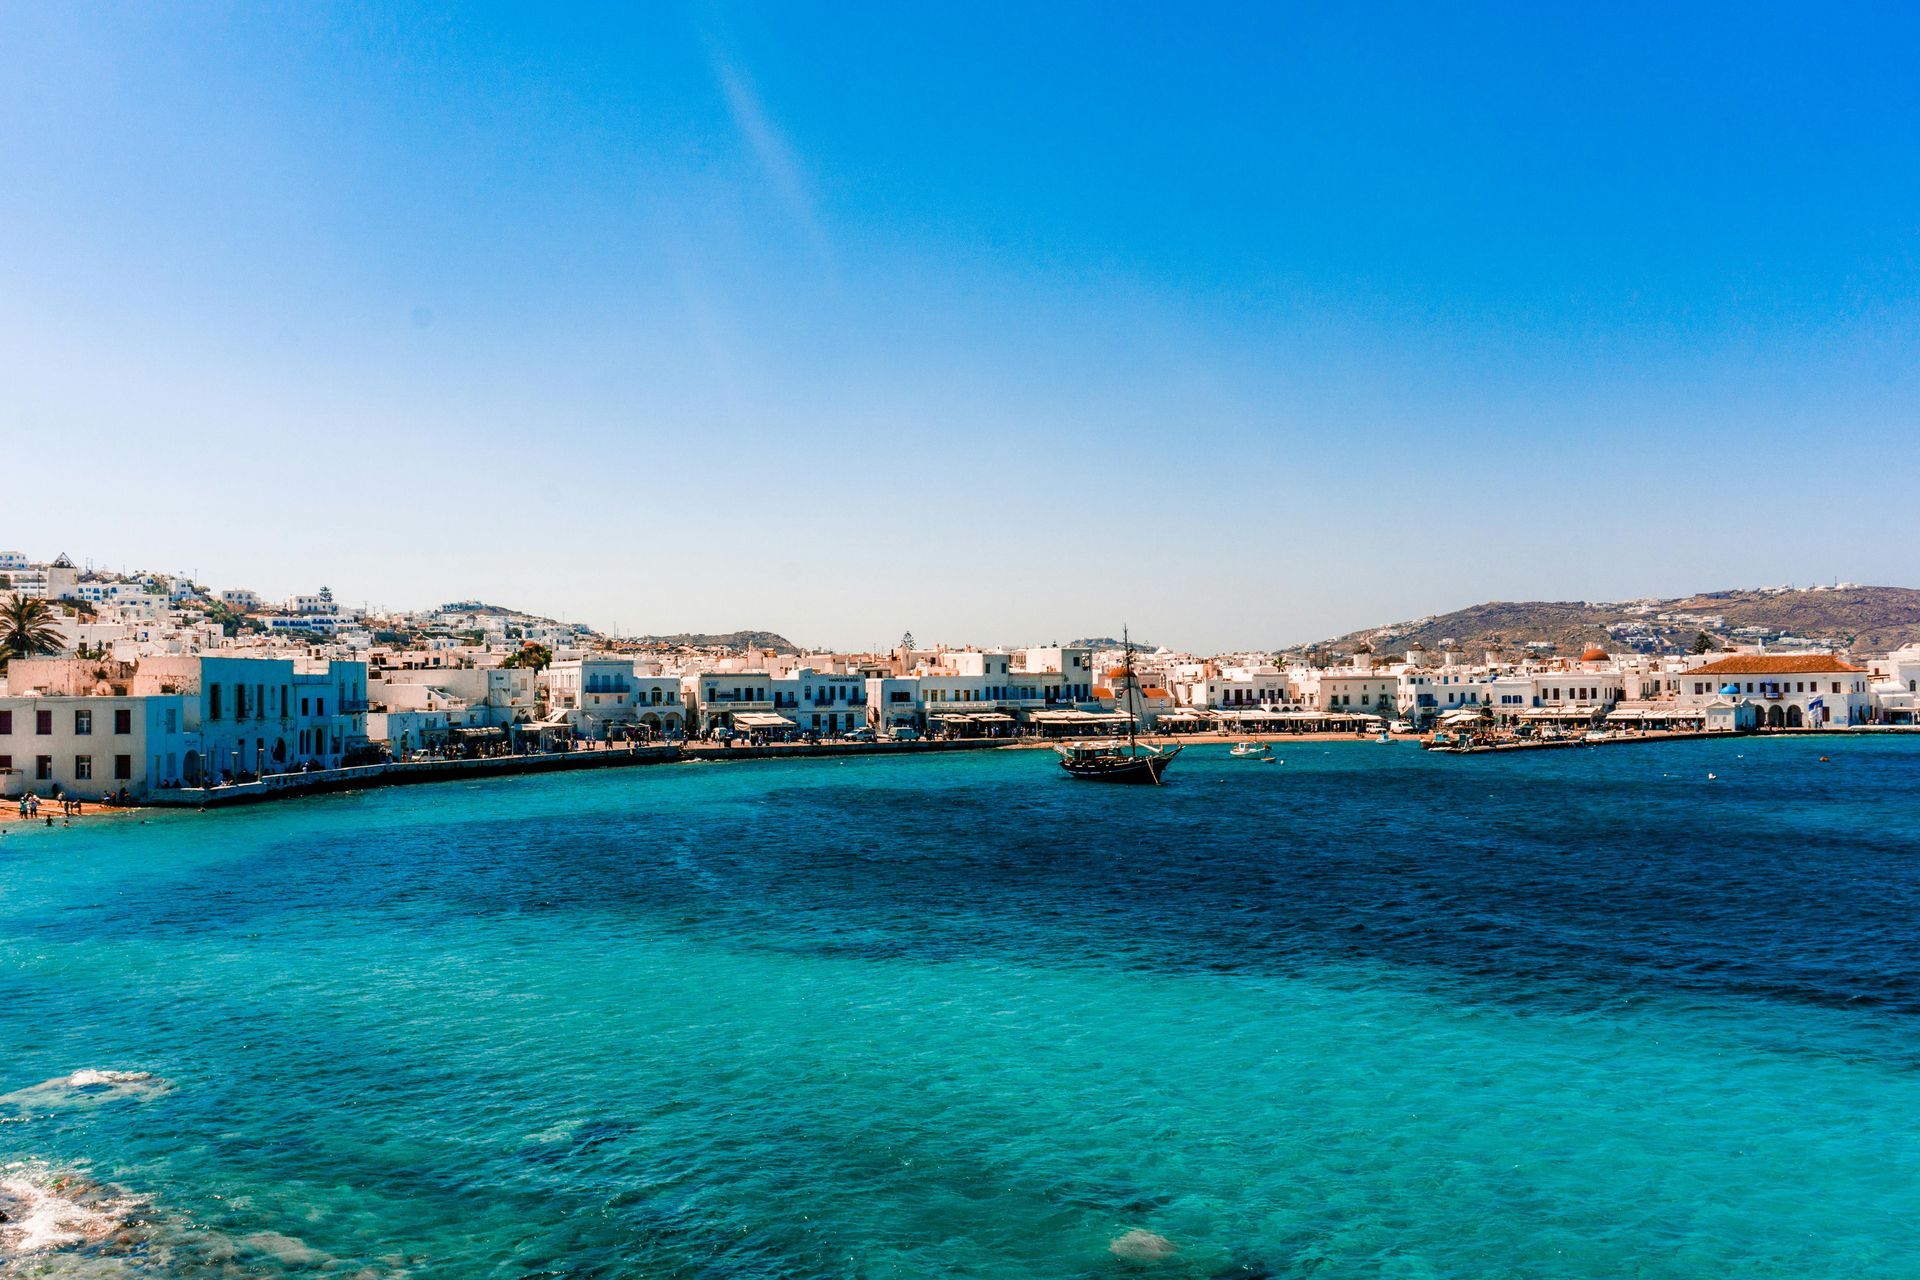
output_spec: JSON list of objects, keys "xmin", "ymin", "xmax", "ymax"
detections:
[{"xmin": 0, "ymin": 739, "xmax": 1920, "ymax": 1280}]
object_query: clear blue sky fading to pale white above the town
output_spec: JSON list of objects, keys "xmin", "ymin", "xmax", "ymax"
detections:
[{"xmin": 0, "ymin": 4, "xmax": 1920, "ymax": 649}]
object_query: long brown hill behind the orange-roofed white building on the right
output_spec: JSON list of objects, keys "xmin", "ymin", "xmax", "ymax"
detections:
[{"xmin": 1288, "ymin": 583, "xmax": 1920, "ymax": 658}]
